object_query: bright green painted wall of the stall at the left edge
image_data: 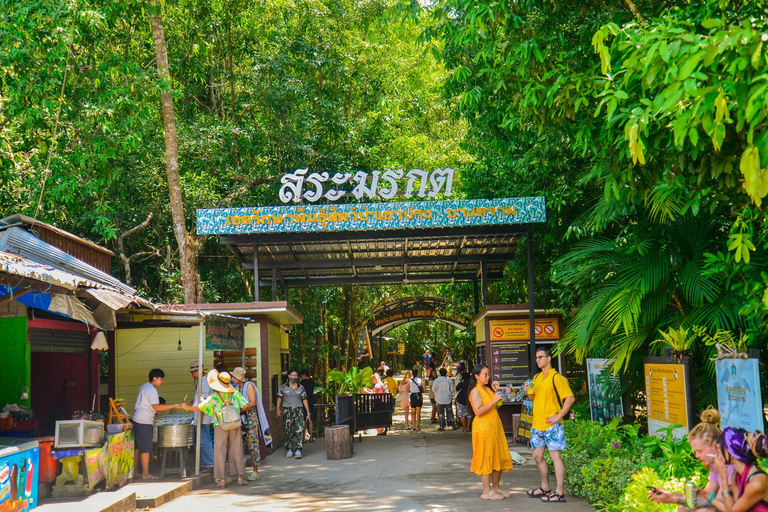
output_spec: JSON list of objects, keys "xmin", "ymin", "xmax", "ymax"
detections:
[{"xmin": 0, "ymin": 316, "xmax": 32, "ymax": 408}]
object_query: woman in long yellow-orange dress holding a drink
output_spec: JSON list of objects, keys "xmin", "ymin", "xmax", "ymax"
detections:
[{"xmin": 469, "ymin": 364, "xmax": 512, "ymax": 500}]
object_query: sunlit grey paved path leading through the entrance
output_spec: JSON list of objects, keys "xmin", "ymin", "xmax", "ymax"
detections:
[{"xmin": 150, "ymin": 406, "xmax": 594, "ymax": 512}]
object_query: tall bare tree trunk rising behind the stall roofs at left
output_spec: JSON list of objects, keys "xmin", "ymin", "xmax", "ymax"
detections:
[{"xmin": 149, "ymin": 4, "xmax": 202, "ymax": 304}]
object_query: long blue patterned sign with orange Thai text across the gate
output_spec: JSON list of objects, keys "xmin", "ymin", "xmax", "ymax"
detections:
[{"xmin": 197, "ymin": 197, "xmax": 547, "ymax": 235}]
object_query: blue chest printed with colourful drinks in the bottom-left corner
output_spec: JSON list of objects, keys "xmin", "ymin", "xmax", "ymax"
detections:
[{"xmin": 0, "ymin": 437, "xmax": 40, "ymax": 512}]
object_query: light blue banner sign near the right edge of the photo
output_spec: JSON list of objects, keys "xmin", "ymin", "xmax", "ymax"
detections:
[{"xmin": 715, "ymin": 359, "xmax": 763, "ymax": 432}]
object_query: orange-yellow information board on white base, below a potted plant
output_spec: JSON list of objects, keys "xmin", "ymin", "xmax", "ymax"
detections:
[{"xmin": 643, "ymin": 358, "xmax": 690, "ymax": 439}]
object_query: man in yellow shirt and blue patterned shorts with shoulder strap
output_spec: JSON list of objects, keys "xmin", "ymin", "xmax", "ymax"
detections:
[{"xmin": 525, "ymin": 348, "xmax": 576, "ymax": 502}]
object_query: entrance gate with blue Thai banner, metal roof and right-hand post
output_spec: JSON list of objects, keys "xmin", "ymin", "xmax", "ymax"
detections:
[{"xmin": 197, "ymin": 197, "xmax": 546, "ymax": 372}]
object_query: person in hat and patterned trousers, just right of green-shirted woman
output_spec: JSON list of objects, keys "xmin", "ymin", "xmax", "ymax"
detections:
[{"xmin": 232, "ymin": 366, "xmax": 272, "ymax": 480}]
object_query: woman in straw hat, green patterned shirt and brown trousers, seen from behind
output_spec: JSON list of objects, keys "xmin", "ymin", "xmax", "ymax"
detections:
[{"xmin": 183, "ymin": 370, "xmax": 248, "ymax": 489}]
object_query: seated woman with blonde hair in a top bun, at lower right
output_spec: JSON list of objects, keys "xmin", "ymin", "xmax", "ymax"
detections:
[{"xmin": 648, "ymin": 407, "xmax": 734, "ymax": 512}]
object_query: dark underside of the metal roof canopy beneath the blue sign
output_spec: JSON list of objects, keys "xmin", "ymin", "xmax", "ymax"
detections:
[{"xmin": 220, "ymin": 224, "xmax": 531, "ymax": 292}]
